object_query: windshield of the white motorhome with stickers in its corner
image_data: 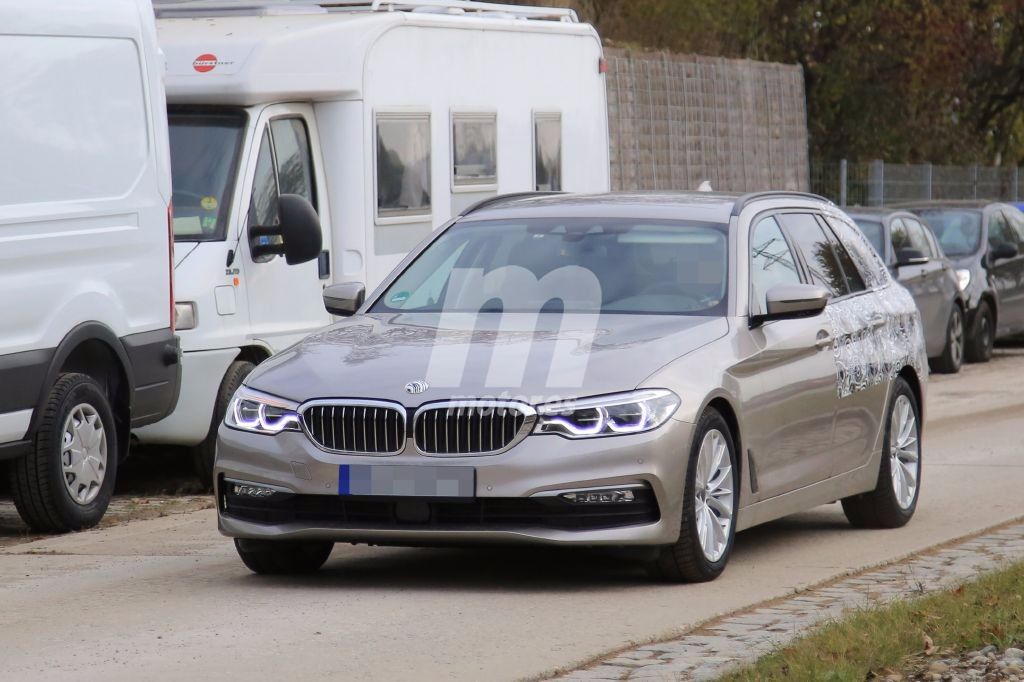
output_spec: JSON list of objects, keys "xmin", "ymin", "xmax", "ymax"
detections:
[{"xmin": 168, "ymin": 110, "xmax": 246, "ymax": 242}]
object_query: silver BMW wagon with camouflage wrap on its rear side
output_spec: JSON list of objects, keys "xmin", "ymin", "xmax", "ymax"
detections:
[{"xmin": 215, "ymin": 193, "xmax": 927, "ymax": 581}]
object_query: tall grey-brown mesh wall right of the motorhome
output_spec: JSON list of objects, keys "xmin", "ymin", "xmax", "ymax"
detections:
[{"xmin": 605, "ymin": 49, "xmax": 808, "ymax": 191}]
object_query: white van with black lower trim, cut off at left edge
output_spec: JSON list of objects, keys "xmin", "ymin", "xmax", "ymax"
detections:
[{"xmin": 0, "ymin": 0, "xmax": 180, "ymax": 531}]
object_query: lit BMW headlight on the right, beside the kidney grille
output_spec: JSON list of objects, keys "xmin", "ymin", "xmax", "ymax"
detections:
[{"xmin": 535, "ymin": 388, "xmax": 679, "ymax": 438}]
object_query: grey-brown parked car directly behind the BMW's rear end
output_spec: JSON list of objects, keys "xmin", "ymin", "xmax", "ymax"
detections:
[{"xmin": 848, "ymin": 208, "xmax": 967, "ymax": 373}]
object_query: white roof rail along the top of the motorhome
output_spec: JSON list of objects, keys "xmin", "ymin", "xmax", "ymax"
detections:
[{"xmin": 153, "ymin": 0, "xmax": 580, "ymax": 24}]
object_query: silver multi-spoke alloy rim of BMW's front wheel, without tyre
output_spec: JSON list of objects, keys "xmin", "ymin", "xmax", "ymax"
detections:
[{"xmin": 693, "ymin": 429, "xmax": 733, "ymax": 561}]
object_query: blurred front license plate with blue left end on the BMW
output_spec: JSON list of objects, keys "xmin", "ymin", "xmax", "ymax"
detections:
[{"xmin": 338, "ymin": 464, "xmax": 476, "ymax": 498}]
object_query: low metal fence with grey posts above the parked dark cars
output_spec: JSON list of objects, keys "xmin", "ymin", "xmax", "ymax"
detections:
[{"xmin": 811, "ymin": 161, "xmax": 1024, "ymax": 206}]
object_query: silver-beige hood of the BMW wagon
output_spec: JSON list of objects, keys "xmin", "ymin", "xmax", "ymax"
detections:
[{"xmin": 246, "ymin": 313, "xmax": 729, "ymax": 407}]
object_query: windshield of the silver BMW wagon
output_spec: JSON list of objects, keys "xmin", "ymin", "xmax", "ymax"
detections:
[{"xmin": 372, "ymin": 218, "xmax": 728, "ymax": 315}]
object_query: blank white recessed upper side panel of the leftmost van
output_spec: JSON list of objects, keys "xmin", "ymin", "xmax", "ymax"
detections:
[{"xmin": 0, "ymin": 35, "xmax": 150, "ymax": 205}]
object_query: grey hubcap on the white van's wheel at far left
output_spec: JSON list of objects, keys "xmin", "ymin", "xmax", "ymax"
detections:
[{"xmin": 60, "ymin": 402, "xmax": 106, "ymax": 505}]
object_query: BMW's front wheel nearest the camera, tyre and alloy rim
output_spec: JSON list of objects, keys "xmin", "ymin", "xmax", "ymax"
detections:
[{"xmin": 651, "ymin": 409, "xmax": 738, "ymax": 583}]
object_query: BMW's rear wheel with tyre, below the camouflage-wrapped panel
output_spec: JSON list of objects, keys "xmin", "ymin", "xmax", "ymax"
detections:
[{"xmin": 843, "ymin": 377, "xmax": 921, "ymax": 528}]
